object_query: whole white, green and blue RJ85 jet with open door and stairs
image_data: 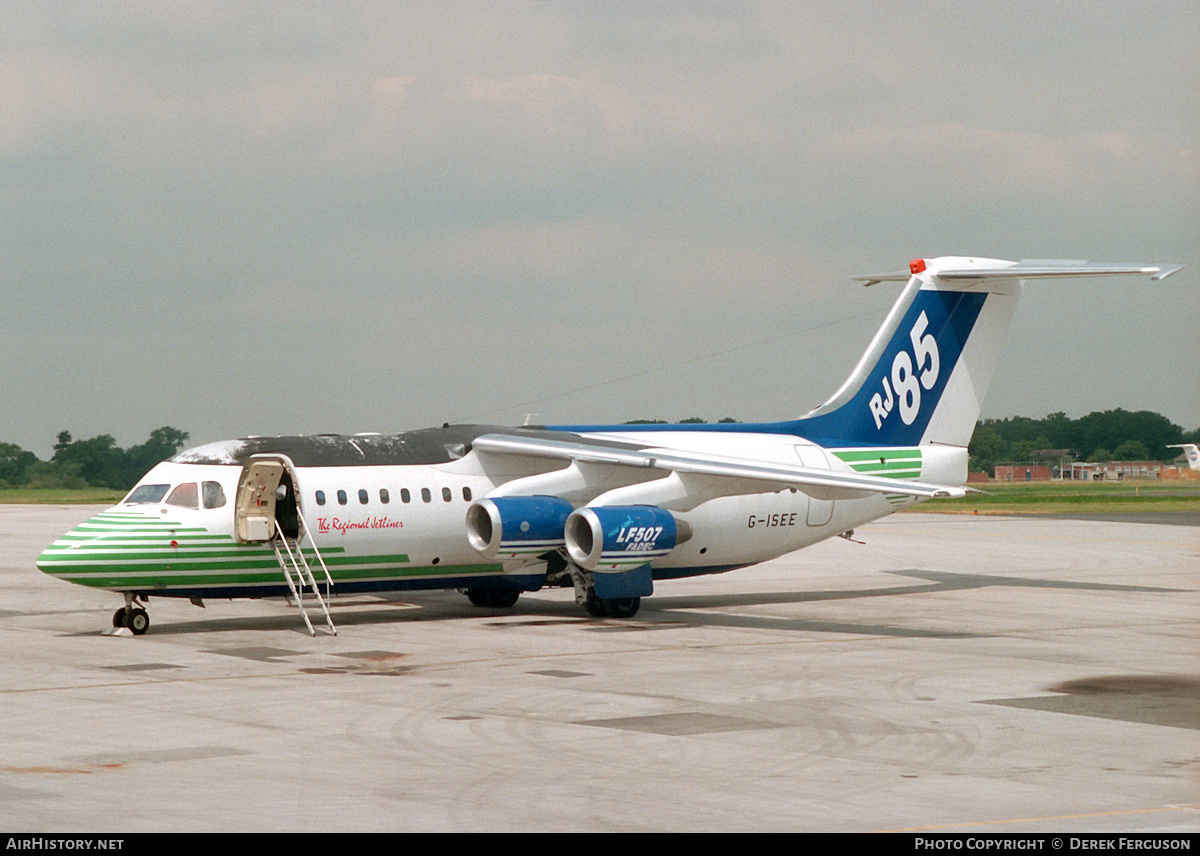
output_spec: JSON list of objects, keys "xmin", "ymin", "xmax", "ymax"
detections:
[{"xmin": 37, "ymin": 257, "xmax": 1182, "ymax": 635}]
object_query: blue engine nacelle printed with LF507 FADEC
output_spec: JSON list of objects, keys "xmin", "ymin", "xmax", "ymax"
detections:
[{"xmin": 566, "ymin": 505, "xmax": 691, "ymax": 573}]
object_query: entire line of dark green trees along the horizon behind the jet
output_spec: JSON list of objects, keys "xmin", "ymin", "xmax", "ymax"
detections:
[{"xmin": 0, "ymin": 409, "xmax": 1200, "ymax": 490}]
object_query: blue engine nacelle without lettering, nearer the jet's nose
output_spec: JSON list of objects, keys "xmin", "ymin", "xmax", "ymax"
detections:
[{"xmin": 467, "ymin": 496, "xmax": 574, "ymax": 559}]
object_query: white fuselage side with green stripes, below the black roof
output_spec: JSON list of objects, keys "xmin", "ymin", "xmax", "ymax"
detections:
[{"xmin": 38, "ymin": 431, "xmax": 966, "ymax": 598}]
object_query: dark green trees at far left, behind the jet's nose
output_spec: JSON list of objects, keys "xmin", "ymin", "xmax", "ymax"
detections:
[{"xmin": 0, "ymin": 425, "xmax": 187, "ymax": 490}]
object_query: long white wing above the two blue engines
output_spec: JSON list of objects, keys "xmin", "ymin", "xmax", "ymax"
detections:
[{"xmin": 472, "ymin": 433, "xmax": 967, "ymax": 498}]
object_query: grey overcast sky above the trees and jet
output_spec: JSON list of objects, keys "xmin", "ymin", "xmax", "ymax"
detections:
[{"xmin": 0, "ymin": 0, "xmax": 1200, "ymax": 457}]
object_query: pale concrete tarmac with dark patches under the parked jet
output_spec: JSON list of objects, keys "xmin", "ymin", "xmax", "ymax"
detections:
[{"xmin": 0, "ymin": 505, "xmax": 1200, "ymax": 834}]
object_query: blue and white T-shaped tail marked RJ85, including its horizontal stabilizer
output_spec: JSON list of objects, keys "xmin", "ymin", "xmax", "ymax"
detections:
[{"xmin": 793, "ymin": 257, "xmax": 1180, "ymax": 447}]
